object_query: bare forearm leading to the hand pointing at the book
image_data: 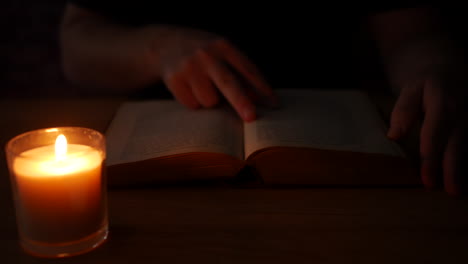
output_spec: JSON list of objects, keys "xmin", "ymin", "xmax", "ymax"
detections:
[{"xmin": 61, "ymin": 5, "xmax": 159, "ymax": 93}]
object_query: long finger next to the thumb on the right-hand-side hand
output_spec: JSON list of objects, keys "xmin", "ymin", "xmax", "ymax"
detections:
[{"xmin": 420, "ymin": 81, "xmax": 451, "ymax": 188}]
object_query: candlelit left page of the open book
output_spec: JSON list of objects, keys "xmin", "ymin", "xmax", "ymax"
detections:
[{"xmin": 106, "ymin": 100, "xmax": 244, "ymax": 165}]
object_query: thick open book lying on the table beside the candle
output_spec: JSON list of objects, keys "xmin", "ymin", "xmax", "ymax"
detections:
[{"xmin": 106, "ymin": 89, "xmax": 419, "ymax": 185}]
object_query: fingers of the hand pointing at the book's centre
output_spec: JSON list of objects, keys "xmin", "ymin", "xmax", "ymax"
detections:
[{"xmin": 164, "ymin": 37, "xmax": 278, "ymax": 122}]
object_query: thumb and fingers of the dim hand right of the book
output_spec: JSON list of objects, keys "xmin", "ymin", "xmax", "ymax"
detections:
[{"xmin": 396, "ymin": 79, "xmax": 468, "ymax": 195}]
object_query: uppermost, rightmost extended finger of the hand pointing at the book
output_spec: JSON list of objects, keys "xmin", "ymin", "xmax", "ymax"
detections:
[{"xmin": 214, "ymin": 40, "xmax": 278, "ymax": 107}]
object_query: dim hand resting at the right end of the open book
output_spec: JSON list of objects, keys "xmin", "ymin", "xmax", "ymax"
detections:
[{"xmin": 388, "ymin": 40, "xmax": 468, "ymax": 195}]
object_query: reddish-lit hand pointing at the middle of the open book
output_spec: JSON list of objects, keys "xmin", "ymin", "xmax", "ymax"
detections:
[{"xmin": 148, "ymin": 28, "xmax": 277, "ymax": 121}]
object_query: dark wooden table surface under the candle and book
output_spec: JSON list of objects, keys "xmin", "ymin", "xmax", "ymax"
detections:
[{"xmin": 0, "ymin": 99, "xmax": 468, "ymax": 264}]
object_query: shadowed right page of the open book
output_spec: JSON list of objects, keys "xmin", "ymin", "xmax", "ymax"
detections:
[{"xmin": 244, "ymin": 89, "xmax": 402, "ymax": 157}]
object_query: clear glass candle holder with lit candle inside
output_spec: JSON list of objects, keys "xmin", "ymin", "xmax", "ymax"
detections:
[{"xmin": 5, "ymin": 127, "xmax": 108, "ymax": 258}]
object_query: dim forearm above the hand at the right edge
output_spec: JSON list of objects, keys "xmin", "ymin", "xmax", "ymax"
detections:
[{"xmin": 370, "ymin": 7, "xmax": 459, "ymax": 89}]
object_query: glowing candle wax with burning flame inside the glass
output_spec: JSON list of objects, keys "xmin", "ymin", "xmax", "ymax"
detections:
[{"xmin": 7, "ymin": 129, "xmax": 107, "ymax": 257}]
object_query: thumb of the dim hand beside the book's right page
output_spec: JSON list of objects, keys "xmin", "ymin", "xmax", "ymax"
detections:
[{"xmin": 387, "ymin": 83, "xmax": 423, "ymax": 140}]
